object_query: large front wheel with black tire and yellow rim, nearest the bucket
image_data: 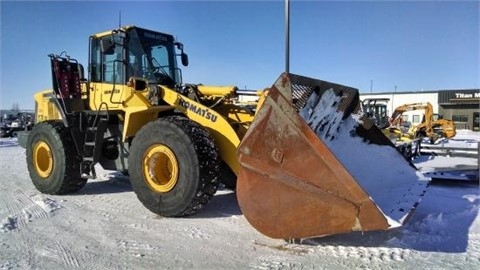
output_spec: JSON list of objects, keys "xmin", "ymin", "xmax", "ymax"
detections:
[{"xmin": 128, "ymin": 116, "xmax": 220, "ymax": 217}]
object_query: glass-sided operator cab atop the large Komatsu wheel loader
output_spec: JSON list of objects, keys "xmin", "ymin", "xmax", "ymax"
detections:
[{"xmin": 89, "ymin": 26, "xmax": 188, "ymax": 86}]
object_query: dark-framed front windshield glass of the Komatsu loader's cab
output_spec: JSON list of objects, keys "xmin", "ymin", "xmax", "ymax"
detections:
[{"xmin": 126, "ymin": 28, "xmax": 179, "ymax": 85}]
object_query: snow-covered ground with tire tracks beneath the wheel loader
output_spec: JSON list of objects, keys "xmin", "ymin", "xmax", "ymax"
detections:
[{"xmin": 0, "ymin": 131, "xmax": 480, "ymax": 269}]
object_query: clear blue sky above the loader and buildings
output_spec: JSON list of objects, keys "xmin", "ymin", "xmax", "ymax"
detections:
[{"xmin": 0, "ymin": 0, "xmax": 480, "ymax": 109}]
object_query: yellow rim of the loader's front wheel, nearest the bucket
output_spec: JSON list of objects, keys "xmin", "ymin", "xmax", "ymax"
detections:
[{"xmin": 143, "ymin": 144, "xmax": 178, "ymax": 193}]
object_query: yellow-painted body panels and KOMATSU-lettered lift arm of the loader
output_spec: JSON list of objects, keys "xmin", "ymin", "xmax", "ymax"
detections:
[{"xmin": 35, "ymin": 80, "xmax": 254, "ymax": 173}]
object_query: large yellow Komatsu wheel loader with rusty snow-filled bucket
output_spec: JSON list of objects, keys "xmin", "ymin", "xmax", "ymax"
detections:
[{"xmin": 19, "ymin": 26, "xmax": 426, "ymax": 239}]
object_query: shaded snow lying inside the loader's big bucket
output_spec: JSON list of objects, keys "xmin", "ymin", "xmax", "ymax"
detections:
[{"xmin": 300, "ymin": 89, "xmax": 429, "ymax": 227}]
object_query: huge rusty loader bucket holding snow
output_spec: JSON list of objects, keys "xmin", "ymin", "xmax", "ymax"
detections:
[{"xmin": 237, "ymin": 73, "xmax": 428, "ymax": 239}]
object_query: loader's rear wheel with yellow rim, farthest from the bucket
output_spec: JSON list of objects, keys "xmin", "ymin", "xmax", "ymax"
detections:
[{"xmin": 26, "ymin": 121, "xmax": 87, "ymax": 195}]
